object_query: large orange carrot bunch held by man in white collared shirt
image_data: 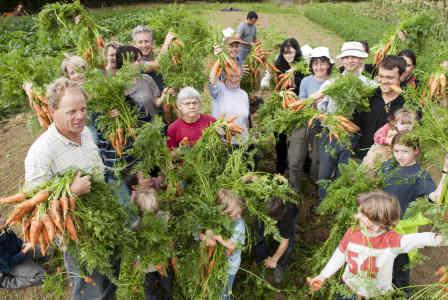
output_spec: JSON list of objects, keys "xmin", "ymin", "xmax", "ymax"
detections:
[{"xmin": 0, "ymin": 171, "xmax": 78, "ymax": 255}]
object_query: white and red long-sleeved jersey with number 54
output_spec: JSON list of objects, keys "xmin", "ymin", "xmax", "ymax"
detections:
[{"xmin": 320, "ymin": 228, "xmax": 440, "ymax": 298}]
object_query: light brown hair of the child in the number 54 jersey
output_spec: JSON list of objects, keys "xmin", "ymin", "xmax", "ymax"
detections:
[{"xmin": 356, "ymin": 191, "xmax": 401, "ymax": 230}]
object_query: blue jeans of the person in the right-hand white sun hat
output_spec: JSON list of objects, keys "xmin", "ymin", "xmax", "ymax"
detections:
[{"xmin": 318, "ymin": 133, "xmax": 351, "ymax": 203}]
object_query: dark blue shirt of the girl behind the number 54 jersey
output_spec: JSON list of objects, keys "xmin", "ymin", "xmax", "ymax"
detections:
[{"xmin": 382, "ymin": 160, "xmax": 436, "ymax": 217}]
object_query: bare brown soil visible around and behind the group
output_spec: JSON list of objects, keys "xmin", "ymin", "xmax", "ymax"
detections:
[{"xmin": 0, "ymin": 2, "xmax": 448, "ymax": 299}]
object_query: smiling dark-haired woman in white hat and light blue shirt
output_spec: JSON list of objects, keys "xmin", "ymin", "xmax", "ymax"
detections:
[{"xmin": 288, "ymin": 47, "xmax": 333, "ymax": 191}]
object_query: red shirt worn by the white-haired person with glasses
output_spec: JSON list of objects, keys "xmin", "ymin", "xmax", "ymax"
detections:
[{"xmin": 166, "ymin": 114, "xmax": 216, "ymax": 149}]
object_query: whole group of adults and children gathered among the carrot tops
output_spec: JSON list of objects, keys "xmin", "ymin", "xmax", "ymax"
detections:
[{"xmin": 0, "ymin": 11, "xmax": 448, "ymax": 299}]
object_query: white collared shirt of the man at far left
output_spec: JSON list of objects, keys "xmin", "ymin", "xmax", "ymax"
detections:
[{"xmin": 25, "ymin": 123, "xmax": 104, "ymax": 189}]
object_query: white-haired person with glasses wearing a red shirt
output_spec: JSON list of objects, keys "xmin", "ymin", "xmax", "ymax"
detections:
[{"xmin": 166, "ymin": 86, "xmax": 216, "ymax": 149}]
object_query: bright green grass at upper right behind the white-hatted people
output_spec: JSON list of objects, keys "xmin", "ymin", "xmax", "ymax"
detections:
[{"xmin": 304, "ymin": 1, "xmax": 448, "ymax": 72}]
